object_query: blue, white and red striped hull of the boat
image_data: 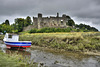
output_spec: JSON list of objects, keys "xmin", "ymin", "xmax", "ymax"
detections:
[{"xmin": 4, "ymin": 41, "xmax": 31, "ymax": 48}]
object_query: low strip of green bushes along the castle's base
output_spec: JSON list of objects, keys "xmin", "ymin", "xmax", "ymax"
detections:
[{"xmin": 29, "ymin": 27, "xmax": 98, "ymax": 33}]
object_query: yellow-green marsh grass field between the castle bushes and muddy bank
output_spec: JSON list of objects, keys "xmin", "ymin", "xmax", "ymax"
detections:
[{"xmin": 20, "ymin": 32, "xmax": 100, "ymax": 51}]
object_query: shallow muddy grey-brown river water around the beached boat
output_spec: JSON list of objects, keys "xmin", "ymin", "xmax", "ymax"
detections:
[{"xmin": 0, "ymin": 41, "xmax": 100, "ymax": 67}]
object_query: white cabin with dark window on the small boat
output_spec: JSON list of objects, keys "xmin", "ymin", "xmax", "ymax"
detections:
[{"xmin": 3, "ymin": 33, "xmax": 19, "ymax": 42}]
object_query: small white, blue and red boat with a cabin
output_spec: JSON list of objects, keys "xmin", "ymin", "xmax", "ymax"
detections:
[{"xmin": 3, "ymin": 33, "xmax": 32, "ymax": 49}]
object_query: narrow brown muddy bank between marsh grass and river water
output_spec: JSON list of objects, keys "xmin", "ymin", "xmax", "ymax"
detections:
[{"xmin": 31, "ymin": 45, "xmax": 100, "ymax": 56}]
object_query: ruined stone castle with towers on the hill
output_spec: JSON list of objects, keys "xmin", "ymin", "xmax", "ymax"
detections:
[{"xmin": 33, "ymin": 13, "xmax": 72, "ymax": 29}]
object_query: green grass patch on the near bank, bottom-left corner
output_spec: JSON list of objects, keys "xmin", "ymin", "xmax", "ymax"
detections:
[{"xmin": 0, "ymin": 51, "xmax": 37, "ymax": 67}]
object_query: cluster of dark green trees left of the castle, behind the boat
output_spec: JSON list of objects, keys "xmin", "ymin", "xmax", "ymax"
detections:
[{"xmin": 0, "ymin": 16, "xmax": 31, "ymax": 33}]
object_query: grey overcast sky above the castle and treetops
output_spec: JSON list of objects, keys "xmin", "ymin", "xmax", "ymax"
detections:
[{"xmin": 0, "ymin": 0, "xmax": 100, "ymax": 30}]
